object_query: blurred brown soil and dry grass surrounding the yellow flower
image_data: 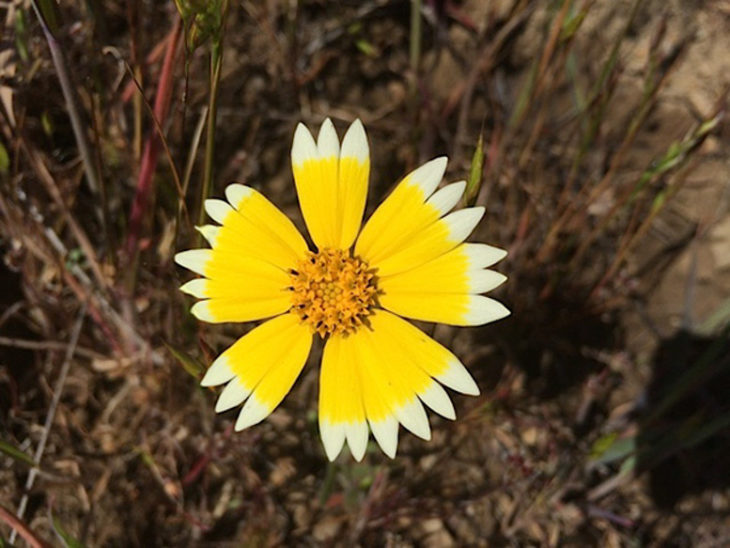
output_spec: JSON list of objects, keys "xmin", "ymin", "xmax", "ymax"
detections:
[{"xmin": 0, "ymin": 0, "xmax": 730, "ymax": 547}]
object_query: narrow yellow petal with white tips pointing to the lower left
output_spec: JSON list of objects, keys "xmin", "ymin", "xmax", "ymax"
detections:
[{"xmin": 202, "ymin": 314, "xmax": 312, "ymax": 430}]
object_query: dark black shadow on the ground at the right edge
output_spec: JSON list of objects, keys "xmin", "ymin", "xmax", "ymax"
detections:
[{"xmin": 637, "ymin": 331, "xmax": 730, "ymax": 509}]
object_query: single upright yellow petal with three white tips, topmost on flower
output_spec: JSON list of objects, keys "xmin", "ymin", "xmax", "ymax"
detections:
[{"xmin": 291, "ymin": 118, "xmax": 370, "ymax": 249}]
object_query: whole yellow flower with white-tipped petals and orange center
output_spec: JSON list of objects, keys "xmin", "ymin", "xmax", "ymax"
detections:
[{"xmin": 175, "ymin": 119, "xmax": 509, "ymax": 460}]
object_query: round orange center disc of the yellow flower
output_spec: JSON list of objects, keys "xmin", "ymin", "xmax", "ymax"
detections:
[{"xmin": 291, "ymin": 249, "xmax": 377, "ymax": 338}]
